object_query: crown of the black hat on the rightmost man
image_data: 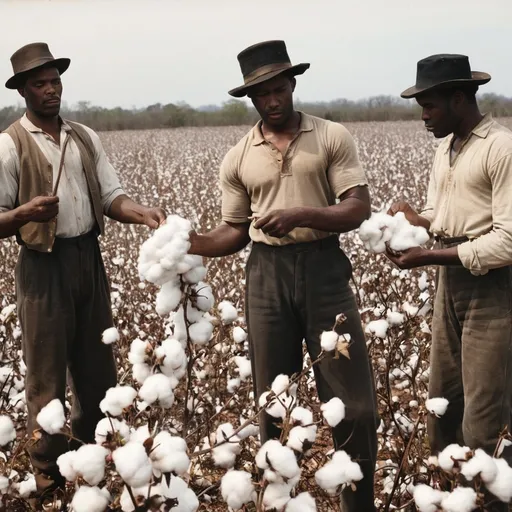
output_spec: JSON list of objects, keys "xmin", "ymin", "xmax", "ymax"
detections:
[{"xmin": 416, "ymin": 53, "xmax": 472, "ymax": 87}]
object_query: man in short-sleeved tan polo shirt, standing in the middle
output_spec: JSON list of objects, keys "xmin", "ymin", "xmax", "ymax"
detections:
[{"xmin": 190, "ymin": 41, "xmax": 377, "ymax": 512}]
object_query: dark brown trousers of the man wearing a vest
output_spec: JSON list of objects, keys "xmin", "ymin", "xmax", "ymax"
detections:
[{"xmin": 16, "ymin": 233, "xmax": 117, "ymax": 492}]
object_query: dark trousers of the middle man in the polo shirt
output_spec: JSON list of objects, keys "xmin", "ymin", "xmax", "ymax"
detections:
[{"xmin": 246, "ymin": 237, "xmax": 378, "ymax": 512}]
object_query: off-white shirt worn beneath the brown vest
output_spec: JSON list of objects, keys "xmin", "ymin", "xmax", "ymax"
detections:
[{"xmin": 0, "ymin": 115, "xmax": 124, "ymax": 238}]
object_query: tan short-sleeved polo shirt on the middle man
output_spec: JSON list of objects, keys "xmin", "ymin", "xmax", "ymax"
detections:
[{"xmin": 220, "ymin": 112, "xmax": 367, "ymax": 245}]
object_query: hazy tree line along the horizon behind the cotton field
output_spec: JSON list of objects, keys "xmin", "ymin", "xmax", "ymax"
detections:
[{"xmin": 0, "ymin": 93, "xmax": 512, "ymax": 131}]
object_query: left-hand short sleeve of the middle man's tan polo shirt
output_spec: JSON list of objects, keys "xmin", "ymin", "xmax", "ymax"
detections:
[{"xmin": 220, "ymin": 148, "xmax": 252, "ymax": 224}]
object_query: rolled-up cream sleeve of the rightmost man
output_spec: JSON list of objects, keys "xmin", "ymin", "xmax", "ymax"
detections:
[{"xmin": 458, "ymin": 153, "xmax": 512, "ymax": 275}]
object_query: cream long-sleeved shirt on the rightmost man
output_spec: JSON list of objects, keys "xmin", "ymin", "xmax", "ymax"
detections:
[{"xmin": 421, "ymin": 114, "xmax": 512, "ymax": 275}]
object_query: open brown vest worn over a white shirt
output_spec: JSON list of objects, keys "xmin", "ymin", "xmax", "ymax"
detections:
[{"xmin": 5, "ymin": 120, "xmax": 105, "ymax": 252}]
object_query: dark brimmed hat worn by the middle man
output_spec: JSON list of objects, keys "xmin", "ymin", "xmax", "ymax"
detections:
[{"xmin": 228, "ymin": 40, "xmax": 310, "ymax": 98}]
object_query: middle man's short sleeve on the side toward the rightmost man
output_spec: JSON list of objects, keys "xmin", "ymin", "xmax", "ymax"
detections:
[{"xmin": 327, "ymin": 123, "xmax": 368, "ymax": 197}]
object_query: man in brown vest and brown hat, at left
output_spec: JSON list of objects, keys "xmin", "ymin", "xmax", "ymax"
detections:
[{"xmin": 0, "ymin": 43, "xmax": 165, "ymax": 506}]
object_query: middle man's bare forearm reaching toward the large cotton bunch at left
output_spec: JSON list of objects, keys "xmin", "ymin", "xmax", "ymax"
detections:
[{"xmin": 189, "ymin": 224, "xmax": 251, "ymax": 258}]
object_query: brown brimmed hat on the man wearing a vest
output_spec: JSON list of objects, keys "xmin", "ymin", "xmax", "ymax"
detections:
[{"xmin": 5, "ymin": 43, "xmax": 71, "ymax": 89}]
